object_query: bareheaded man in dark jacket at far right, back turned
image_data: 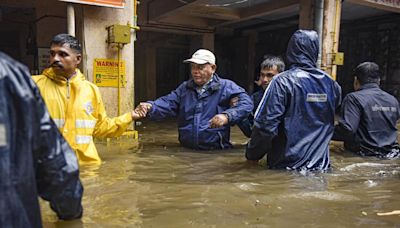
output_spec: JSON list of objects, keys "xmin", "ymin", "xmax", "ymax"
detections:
[{"xmin": 333, "ymin": 62, "xmax": 400, "ymax": 158}]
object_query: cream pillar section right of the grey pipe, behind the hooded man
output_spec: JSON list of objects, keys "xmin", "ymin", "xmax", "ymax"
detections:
[{"xmin": 321, "ymin": 0, "xmax": 342, "ymax": 80}]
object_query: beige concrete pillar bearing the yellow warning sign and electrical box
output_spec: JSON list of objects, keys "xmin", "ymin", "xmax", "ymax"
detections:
[{"xmin": 77, "ymin": 1, "xmax": 134, "ymax": 116}]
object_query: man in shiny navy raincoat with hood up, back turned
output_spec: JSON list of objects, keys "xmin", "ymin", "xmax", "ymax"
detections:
[{"xmin": 246, "ymin": 30, "xmax": 341, "ymax": 171}]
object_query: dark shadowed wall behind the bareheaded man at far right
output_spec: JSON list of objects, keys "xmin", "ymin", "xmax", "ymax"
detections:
[{"xmin": 337, "ymin": 14, "xmax": 400, "ymax": 100}]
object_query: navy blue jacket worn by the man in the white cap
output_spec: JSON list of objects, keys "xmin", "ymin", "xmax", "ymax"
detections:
[{"xmin": 148, "ymin": 74, "xmax": 253, "ymax": 150}]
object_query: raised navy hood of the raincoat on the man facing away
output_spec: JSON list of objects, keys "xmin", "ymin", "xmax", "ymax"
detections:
[{"xmin": 286, "ymin": 30, "xmax": 319, "ymax": 69}]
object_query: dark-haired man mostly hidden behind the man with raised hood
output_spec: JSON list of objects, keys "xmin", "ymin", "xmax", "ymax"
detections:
[{"xmin": 237, "ymin": 55, "xmax": 285, "ymax": 138}]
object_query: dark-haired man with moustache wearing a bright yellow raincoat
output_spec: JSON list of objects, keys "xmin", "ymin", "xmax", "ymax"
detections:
[{"xmin": 33, "ymin": 34, "xmax": 140, "ymax": 164}]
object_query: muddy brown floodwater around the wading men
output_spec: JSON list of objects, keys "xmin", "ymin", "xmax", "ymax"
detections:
[{"xmin": 41, "ymin": 122, "xmax": 400, "ymax": 227}]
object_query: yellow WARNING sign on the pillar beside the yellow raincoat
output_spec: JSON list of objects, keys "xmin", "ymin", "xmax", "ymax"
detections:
[{"xmin": 93, "ymin": 59, "xmax": 126, "ymax": 88}]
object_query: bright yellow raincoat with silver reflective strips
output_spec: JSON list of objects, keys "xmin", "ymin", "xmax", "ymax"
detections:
[{"xmin": 33, "ymin": 68, "xmax": 132, "ymax": 164}]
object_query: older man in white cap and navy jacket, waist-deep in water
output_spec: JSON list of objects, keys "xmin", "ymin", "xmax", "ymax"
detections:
[{"xmin": 136, "ymin": 49, "xmax": 253, "ymax": 150}]
